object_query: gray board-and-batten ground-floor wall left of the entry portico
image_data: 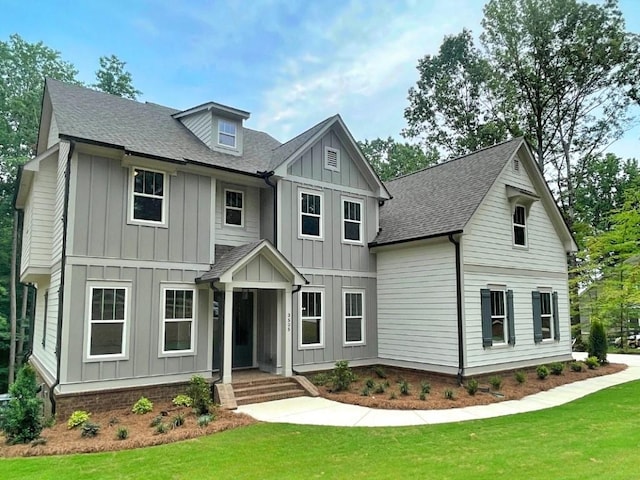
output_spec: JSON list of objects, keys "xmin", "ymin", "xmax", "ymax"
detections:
[{"xmin": 66, "ymin": 266, "xmax": 212, "ymax": 383}]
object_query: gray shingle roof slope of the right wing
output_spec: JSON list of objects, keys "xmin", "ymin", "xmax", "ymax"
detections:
[{"xmin": 373, "ymin": 138, "xmax": 524, "ymax": 245}]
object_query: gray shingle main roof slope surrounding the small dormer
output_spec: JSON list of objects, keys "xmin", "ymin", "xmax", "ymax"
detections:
[{"xmin": 47, "ymin": 79, "xmax": 280, "ymax": 174}]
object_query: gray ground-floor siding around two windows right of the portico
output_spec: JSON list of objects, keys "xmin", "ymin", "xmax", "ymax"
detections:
[{"xmin": 292, "ymin": 275, "xmax": 378, "ymax": 367}]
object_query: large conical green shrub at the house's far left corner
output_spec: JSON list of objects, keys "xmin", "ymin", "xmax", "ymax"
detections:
[{"xmin": 0, "ymin": 365, "xmax": 42, "ymax": 444}]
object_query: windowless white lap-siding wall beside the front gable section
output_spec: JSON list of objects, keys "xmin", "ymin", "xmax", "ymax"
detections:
[{"xmin": 377, "ymin": 242, "xmax": 458, "ymax": 366}]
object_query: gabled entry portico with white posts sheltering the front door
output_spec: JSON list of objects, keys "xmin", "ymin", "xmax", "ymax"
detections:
[{"xmin": 196, "ymin": 240, "xmax": 307, "ymax": 383}]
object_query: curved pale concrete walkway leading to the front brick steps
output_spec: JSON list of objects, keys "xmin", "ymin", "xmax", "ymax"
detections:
[{"xmin": 237, "ymin": 353, "xmax": 640, "ymax": 427}]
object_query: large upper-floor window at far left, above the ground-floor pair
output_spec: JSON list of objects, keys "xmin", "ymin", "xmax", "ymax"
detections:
[{"xmin": 131, "ymin": 168, "xmax": 166, "ymax": 224}]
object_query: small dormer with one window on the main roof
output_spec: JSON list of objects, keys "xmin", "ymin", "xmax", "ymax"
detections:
[{"xmin": 173, "ymin": 102, "xmax": 250, "ymax": 155}]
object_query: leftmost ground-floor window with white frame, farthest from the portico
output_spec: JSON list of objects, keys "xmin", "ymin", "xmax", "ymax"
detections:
[{"xmin": 87, "ymin": 284, "xmax": 128, "ymax": 359}]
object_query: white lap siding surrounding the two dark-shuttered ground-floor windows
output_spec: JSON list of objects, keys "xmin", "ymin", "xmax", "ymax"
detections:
[{"xmin": 464, "ymin": 272, "xmax": 571, "ymax": 367}]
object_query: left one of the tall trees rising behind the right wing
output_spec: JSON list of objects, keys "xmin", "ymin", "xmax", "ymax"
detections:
[{"xmin": 403, "ymin": 30, "xmax": 519, "ymax": 156}]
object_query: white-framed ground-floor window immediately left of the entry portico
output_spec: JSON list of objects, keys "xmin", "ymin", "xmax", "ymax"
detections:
[{"xmin": 162, "ymin": 286, "xmax": 196, "ymax": 354}]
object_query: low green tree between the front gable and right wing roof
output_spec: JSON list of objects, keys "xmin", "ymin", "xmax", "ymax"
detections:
[{"xmin": 358, "ymin": 137, "xmax": 438, "ymax": 181}]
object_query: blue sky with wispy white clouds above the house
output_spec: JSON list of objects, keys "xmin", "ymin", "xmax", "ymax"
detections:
[{"xmin": 0, "ymin": 0, "xmax": 640, "ymax": 157}]
